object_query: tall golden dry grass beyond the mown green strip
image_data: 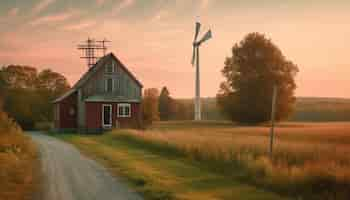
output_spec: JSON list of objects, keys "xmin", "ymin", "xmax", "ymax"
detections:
[{"xmin": 117, "ymin": 123, "xmax": 350, "ymax": 200}]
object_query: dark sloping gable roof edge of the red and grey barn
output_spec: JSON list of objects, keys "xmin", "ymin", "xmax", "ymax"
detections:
[{"xmin": 53, "ymin": 53, "xmax": 143, "ymax": 103}]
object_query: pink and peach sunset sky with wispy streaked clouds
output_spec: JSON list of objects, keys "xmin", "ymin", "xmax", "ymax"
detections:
[{"xmin": 0, "ymin": 0, "xmax": 350, "ymax": 97}]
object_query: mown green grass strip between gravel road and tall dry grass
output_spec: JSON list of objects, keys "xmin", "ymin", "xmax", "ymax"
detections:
[{"xmin": 55, "ymin": 131, "xmax": 288, "ymax": 200}]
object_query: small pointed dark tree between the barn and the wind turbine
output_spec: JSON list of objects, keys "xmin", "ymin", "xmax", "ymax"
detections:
[{"xmin": 159, "ymin": 87, "xmax": 176, "ymax": 120}]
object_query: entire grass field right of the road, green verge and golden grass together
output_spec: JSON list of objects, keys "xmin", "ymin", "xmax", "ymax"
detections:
[{"xmin": 55, "ymin": 122, "xmax": 350, "ymax": 200}]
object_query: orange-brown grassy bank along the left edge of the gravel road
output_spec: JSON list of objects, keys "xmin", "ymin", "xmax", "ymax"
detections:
[{"xmin": 0, "ymin": 112, "xmax": 39, "ymax": 200}]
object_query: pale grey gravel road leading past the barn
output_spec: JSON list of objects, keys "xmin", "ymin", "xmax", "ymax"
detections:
[{"xmin": 31, "ymin": 133, "xmax": 142, "ymax": 200}]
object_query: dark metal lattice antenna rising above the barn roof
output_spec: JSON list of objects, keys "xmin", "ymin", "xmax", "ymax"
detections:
[{"xmin": 78, "ymin": 38, "xmax": 110, "ymax": 68}]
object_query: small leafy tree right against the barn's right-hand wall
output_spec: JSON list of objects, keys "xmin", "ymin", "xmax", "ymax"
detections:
[{"xmin": 142, "ymin": 88, "xmax": 159, "ymax": 125}]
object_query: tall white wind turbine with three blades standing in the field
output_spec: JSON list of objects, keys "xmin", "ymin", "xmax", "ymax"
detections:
[{"xmin": 191, "ymin": 22, "xmax": 212, "ymax": 121}]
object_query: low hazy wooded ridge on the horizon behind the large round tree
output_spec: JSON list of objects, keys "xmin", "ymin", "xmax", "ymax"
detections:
[{"xmin": 178, "ymin": 97, "xmax": 350, "ymax": 122}]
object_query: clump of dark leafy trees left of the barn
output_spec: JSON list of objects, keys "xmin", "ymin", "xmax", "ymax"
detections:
[{"xmin": 0, "ymin": 65, "xmax": 70, "ymax": 129}]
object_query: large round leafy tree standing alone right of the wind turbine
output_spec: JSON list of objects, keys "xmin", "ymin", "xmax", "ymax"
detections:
[{"xmin": 217, "ymin": 33, "xmax": 298, "ymax": 123}]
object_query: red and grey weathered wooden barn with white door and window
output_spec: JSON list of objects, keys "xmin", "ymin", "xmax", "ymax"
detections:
[{"xmin": 54, "ymin": 53, "xmax": 143, "ymax": 132}]
